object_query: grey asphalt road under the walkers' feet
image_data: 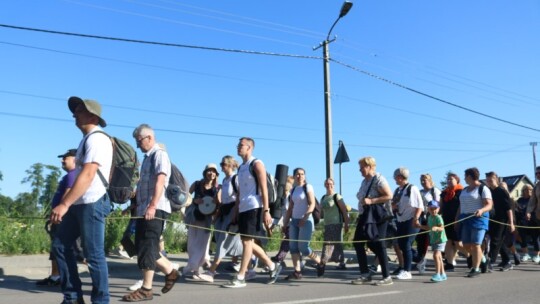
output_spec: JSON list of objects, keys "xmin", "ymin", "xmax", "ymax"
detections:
[{"xmin": 0, "ymin": 253, "xmax": 540, "ymax": 304}]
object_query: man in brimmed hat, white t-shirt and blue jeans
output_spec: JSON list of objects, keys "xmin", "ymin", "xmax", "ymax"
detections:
[{"xmin": 51, "ymin": 97, "xmax": 113, "ymax": 303}]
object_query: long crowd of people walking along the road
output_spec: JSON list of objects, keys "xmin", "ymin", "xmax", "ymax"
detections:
[{"xmin": 37, "ymin": 97, "xmax": 540, "ymax": 303}]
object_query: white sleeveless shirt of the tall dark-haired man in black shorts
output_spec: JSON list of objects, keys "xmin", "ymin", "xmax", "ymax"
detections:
[{"xmin": 237, "ymin": 156, "xmax": 266, "ymax": 212}]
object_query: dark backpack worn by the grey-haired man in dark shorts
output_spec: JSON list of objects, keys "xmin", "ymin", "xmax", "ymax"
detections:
[{"xmin": 151, "ymin": 152, "xmax": 192, "ymax": 212}]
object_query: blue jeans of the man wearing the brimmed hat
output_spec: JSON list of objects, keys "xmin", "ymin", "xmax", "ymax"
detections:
[{"xmin": 53, "ymin": 195, "xmax": 111, "ymax": 303}]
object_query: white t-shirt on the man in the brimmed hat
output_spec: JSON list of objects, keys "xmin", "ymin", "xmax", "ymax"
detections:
[{"xmin": 74, "ymin": 126, "xmax": 113, "ymax": 205}]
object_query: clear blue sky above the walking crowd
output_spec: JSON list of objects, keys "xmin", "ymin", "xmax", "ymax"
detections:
[{"xmin": 0, "ymin": 0, "xmax": 540, "ymax": 206}]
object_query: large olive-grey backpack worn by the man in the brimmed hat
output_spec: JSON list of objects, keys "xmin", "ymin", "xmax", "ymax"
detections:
[{"xmin": 83, "ymin": 131, "xmax": 139, "ymax": 204}]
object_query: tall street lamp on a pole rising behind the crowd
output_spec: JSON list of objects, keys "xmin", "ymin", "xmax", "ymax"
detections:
[{"xmin": 313, "ymin": 1, "xmax": 352, "ymax": 178}]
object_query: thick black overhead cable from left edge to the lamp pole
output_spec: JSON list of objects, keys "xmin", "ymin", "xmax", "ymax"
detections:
[{"xmin": 0, "ymin": 24, "xmax": 322, "ymax": 59}]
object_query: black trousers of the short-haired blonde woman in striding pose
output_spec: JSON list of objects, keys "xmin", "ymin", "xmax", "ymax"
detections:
[{"xmin": 354, "ymin": 221, "xmax": 390, "ymax": 278}]
